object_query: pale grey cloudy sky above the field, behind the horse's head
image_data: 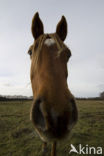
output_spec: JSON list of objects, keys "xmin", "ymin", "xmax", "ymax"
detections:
[{"xmin": 0, "ymin": 0, "xmax": 104, "ymax": 97}]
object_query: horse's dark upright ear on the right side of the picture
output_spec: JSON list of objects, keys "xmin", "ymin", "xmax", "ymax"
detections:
[{"xmin": 56, "ymin": 16, "xmax": 67, "ymax": 41}]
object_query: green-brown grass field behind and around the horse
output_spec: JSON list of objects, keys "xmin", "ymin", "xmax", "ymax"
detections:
[{"xmin": 0, "ymin": 100, "xmax": 104, "ymax": 156}]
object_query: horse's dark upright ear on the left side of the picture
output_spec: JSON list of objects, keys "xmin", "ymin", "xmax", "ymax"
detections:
[{"xmin": 31, "ymin": 12, "xmax": 44, "ymax": 39}]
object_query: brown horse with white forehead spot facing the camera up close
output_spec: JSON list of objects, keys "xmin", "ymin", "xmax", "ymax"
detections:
[{"xmin": 28, "ymin": 13, "xmax": 78, "ymax": 156}]
